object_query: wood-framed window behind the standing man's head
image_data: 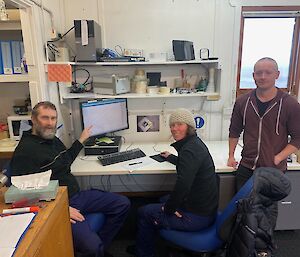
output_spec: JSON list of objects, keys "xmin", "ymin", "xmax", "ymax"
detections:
[{"xmin": 237, "ymin": 6, "xmax": 300, "ymax": 95}]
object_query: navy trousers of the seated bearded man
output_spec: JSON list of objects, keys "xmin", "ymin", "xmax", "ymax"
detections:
[{"xmin": 70, "ymin": 189, "xmax": 130, "ymax": 256}]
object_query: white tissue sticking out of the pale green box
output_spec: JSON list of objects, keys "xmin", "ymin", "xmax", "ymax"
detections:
[{"xmin": 11, "ymin": 170, "xmax": 52, "ymax": 190}]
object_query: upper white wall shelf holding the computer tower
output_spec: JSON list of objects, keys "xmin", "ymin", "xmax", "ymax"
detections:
[{"xmin": 45, "ymin": 60, "xmax": 219, "ymax": 66}]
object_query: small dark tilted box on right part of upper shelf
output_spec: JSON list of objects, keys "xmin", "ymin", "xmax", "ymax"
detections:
[{"xmin": 172, "ymin": 40, "xmax": 195, "ymax": 61}]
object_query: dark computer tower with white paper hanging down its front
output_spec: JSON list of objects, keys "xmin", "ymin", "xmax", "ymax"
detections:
[{"xmin": 74, "ymin": 20, "xmax": 102, "ymax": 62}]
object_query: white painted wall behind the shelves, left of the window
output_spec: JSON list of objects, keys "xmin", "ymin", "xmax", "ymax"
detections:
[{"xmin": 42, "ymin": 0, "xmax": 299, "ymax": 140}]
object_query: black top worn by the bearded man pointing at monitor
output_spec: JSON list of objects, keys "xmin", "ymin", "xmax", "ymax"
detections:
[{"xmin": 11, "ymin": 131, "xmax": 83, "ymax": 198}]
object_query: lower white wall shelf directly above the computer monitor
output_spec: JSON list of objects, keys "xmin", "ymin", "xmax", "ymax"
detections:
[{"xmin": 63, "ymin": 92, "xmax": 220, "ymax": 100}]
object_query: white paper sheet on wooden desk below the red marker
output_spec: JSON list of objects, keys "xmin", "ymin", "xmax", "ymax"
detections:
[{"xmin": 0, "ymin": 210, "xmax": 35, "ymax": 248}]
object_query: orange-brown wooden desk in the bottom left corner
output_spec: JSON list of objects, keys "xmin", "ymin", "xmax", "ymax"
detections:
[{"xmin": 0, "ymin": 187, "xmax": 74, "ymax": 257}]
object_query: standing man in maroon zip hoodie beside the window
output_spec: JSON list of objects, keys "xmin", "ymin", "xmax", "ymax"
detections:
[{"xmin": 227, "ymin": 57, "xmax": 300, "ymax": 190}]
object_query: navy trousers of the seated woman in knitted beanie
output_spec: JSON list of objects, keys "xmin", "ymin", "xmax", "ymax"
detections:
[{"xmin": 136, "ymin": 203, "xmax": 215, "ymax": 257}]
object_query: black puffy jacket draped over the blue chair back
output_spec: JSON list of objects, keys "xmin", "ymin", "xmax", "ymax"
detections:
[{"xmin": 226, "ymin": 168, "xmax": 291, "ymax": 257}]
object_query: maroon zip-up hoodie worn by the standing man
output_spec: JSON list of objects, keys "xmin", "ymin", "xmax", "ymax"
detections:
[{"xmin": 229, "ymin": 90, "xmax": 300, "ymax": 171}]
